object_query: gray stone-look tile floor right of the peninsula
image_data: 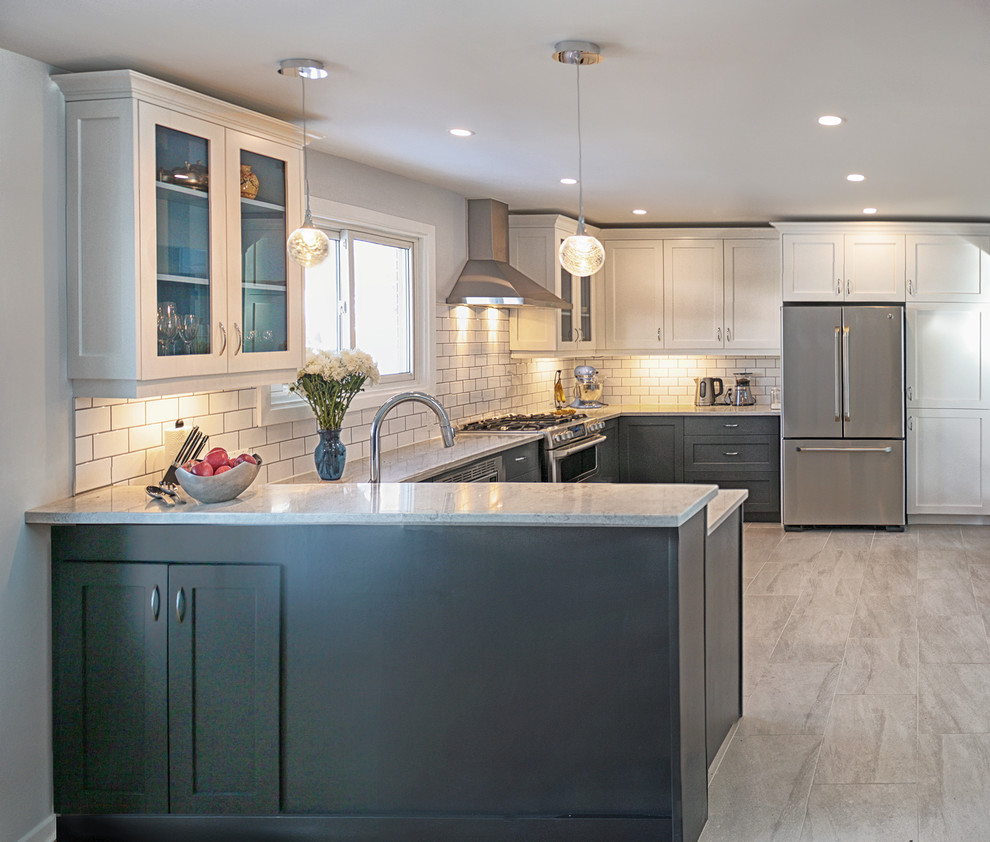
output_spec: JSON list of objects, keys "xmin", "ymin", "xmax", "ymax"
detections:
[{"xmin": 701, "ymin": 524, "xmax": 990, "ymax": 842}]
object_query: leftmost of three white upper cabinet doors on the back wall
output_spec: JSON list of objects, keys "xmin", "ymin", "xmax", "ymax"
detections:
[{"xmin": 603, "ymin": 240, "xmax": 664, "ymax": 351}]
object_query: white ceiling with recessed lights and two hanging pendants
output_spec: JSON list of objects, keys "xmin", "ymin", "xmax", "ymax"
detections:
[{"xmin": 0, "ymin": 0, "xmax": 990, "ymax": 225}]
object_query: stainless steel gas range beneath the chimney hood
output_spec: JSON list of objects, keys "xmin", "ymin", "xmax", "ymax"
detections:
[{"xmin": 458, "ymin": 412, "xmax": 605, "ymax": 482}]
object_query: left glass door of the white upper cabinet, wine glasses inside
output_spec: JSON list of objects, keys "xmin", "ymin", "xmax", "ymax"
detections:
[{"xmin": 139, "ymin": 103, "xmax": 227, "ymax": 378}]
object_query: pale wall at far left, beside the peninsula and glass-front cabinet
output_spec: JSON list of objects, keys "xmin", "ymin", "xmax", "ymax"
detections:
[{"xmin": 0, "ymin": 50, "xmax": 72, "ymax": 842}]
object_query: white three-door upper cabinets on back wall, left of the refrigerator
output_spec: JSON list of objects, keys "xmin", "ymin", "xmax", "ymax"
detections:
[{"xmin": 602, "ymin": 229, "xmax": 780, "ymax": 354}]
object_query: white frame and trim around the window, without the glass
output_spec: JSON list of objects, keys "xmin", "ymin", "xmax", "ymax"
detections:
[{"xmin": 257, "ymin": 196, "xmax": 436, "ymax": 427}]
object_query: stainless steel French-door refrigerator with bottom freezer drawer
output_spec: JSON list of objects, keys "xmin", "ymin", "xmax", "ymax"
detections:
[{"xmin": 781, "ymin": 304, "xmax": 906, "ymax": 529}]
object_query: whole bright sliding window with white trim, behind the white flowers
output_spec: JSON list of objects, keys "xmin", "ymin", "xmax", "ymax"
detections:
[{"xmin": 258, "ymin": 198, "xmax": 435, "ymax": 425}]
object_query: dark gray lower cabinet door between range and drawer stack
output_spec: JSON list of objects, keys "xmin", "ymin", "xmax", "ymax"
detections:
[{"xmin": 619, "ymin": 415, "xmax": 684, "ymax": 482}]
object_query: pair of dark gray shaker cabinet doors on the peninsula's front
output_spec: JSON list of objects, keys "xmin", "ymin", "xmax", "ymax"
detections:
[{"xmin": 52, "ymin": 560, "xmax": 281, "ymax": 814}]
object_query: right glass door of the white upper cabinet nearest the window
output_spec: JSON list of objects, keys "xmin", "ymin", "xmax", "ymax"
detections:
[{"xmin": 227, "ymin": 131, "xmax": 303, "ymax": 371}]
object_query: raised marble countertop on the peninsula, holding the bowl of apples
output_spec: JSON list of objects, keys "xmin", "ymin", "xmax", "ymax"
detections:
[{"xmin": 25, "ymin": 483, "xmax": 718, "ymax": 527}]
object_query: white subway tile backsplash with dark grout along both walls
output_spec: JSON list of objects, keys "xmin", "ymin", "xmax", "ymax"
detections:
[{"xmin": 75, "ymin": 305, "xmax": 780, "ymax": 491}]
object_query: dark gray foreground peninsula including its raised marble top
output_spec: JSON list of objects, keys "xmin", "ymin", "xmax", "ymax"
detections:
[{"xmin": 42, "ymin": 483, "xmax": 720, "ymax": 842}]
